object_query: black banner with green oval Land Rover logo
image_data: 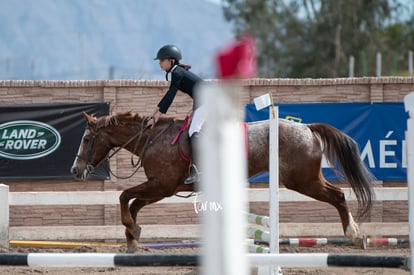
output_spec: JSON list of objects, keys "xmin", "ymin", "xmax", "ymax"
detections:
[{"xmin": 0, "ymin": 103, "xmax": 109, "ymax": 181}]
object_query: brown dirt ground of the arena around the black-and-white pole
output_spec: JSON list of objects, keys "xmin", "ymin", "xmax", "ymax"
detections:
[{"xmin": 0, "ymin": 245, "xmax": 409, "ymax": 275}]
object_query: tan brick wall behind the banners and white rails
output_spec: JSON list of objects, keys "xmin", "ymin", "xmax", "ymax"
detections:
[{"xmin": 0, "ymin": 77, "xmax": 414, "ymax": 231}]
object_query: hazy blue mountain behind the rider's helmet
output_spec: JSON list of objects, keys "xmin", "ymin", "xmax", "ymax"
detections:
[{"xmin": 0, "ymin": 0, "xmax": 234, "ymax": 80}]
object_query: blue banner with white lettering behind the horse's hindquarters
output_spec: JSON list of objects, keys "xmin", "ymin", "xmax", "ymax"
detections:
[{"xmin": 245, "ymin": 103, "xmax": 408, "ymax": 182}]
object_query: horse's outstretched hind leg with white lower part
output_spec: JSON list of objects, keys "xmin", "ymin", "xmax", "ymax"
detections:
[{"xmin": 294, "ymin": 180, "xmax": 363, "ymax": 246}]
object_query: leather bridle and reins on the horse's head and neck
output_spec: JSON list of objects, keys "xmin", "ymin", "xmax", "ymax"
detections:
[{"xmin": 76, "ymin": 117, "xmax": 174, "ymax": 179}]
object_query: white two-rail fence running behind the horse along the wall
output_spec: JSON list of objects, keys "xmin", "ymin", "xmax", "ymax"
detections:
[{"xmin": 0, "ymin": 187, "xmax": 408, "ymax": 247}]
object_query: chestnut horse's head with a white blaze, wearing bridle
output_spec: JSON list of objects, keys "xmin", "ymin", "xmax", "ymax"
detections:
[{"xmin": 71, "ymin": 113, "xmax": 111, "ymax": 180}]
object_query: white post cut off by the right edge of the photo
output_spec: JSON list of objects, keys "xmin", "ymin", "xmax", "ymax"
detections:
[{"xmin": 404, "ymin": 92, "xmax": 414, "ymax": 274}]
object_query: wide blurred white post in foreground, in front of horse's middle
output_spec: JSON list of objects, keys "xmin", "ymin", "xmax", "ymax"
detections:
[{"xmin": 200, "ymin": 84, "xmax": 248, "ymax": 275}]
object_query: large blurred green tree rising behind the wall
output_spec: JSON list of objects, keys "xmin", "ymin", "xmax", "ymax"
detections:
[{"xmin": 223, "ymin": 0, "xmax": 413, "ymax": 77}]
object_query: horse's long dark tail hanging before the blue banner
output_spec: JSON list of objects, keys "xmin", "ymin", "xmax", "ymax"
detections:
[{"xmin": 308, "ymin": 123, "xmax": 374, "ymax": 219}]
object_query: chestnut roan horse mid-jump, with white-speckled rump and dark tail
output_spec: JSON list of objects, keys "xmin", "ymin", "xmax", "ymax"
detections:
[{"xmin": 71, "ymin": 112, "xmax": 374, "ymax": 253}]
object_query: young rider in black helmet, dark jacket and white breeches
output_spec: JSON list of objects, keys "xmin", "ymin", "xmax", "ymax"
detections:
[{"xmin": 147, "ymin": 45, "xmax": 204, "ymax": 184}]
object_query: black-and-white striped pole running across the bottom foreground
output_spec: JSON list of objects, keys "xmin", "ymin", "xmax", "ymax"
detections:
[{"xmin": 0, "ymin": 253, "xmax": 408, "ymax": 269}]
